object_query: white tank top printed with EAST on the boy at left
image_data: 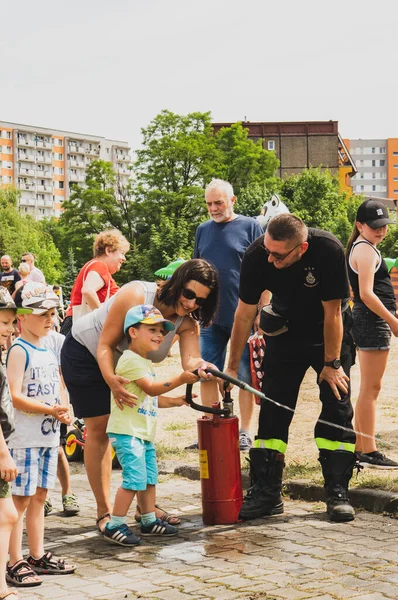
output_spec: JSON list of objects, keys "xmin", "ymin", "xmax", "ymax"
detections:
[{"xmin": 8, "ymin": 338, "xmax": 60, "ymax": 448}]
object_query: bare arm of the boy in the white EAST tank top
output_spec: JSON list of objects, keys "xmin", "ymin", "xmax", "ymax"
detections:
[{"xmin": 7, "ymin": 346, "xmax": 68, "ymax": 419}]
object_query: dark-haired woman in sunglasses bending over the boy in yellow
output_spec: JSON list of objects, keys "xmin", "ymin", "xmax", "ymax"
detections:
[{"xmin": 61, "ymin": 259, "xmax": 219, "ymax": 531}]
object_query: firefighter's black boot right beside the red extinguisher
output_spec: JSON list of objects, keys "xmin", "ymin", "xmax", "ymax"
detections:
[{"xmin": 239, "ymin": 448, "xmax": 285, "ymax": 519}]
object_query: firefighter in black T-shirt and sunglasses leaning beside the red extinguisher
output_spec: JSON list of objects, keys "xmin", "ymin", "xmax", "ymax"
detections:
[{"xmin": 228, "ymin": 214, "xmax": 355, "ymax": 521}]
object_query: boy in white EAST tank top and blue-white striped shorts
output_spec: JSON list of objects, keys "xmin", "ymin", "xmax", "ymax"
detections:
[{"xmin": 7, "ymin": 281, "xmax": 75, "ymax": 587}]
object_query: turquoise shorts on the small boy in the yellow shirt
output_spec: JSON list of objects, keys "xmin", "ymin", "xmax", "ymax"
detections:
[{"xmin": 108, "ymin": 433, "xmax": 158, "ymax": 492}]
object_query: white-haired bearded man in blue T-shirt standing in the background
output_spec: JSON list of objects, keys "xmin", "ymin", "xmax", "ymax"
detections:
[{"xmin": 193, "ymin": 179, "xmax": 263, "ymax": 451}]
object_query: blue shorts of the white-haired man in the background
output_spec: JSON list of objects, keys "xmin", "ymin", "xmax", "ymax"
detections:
[{"xmin": 200, "ymin": 325, "xmax": 252, "ymax": 385}]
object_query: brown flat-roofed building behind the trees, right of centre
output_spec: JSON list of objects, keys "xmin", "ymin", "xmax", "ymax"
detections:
[{"xmin": 213, "ymin": 121, "xmax": 356, "ymax": 193}]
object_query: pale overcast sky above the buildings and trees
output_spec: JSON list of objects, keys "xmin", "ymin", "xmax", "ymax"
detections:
[{"xmin": 0, "ymin": 0, "xmax": 398, "ymax": 149}]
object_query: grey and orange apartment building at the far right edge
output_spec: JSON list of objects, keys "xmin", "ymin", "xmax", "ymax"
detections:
[{"xmin": 346, "ymin": 138, "xmax": 398, "ymax": 200}]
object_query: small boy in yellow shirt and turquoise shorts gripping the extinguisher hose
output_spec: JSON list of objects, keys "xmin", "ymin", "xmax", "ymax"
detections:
[{"xmin": 104, "ymin": 305, "xmax": 198, "ymax": 546}]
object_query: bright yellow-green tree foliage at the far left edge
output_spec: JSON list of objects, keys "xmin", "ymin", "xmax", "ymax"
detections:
[{"xmin": 0, "ymin": 188, "xmax": 63, "ymax": 284}]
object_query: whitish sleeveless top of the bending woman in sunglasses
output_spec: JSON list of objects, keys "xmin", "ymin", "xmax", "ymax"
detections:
[{"xmin": 72, "ymin": 281, "xmax": 184, "ymax": 364}]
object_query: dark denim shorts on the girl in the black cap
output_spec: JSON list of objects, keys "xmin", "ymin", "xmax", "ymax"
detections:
[{"xmin": 352, "ymin": 306, "xmax": 395, "ymax": 350}]
